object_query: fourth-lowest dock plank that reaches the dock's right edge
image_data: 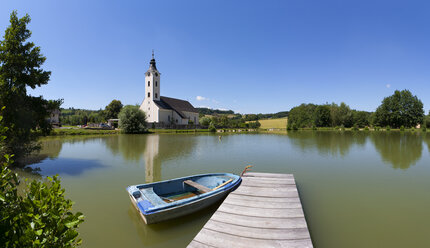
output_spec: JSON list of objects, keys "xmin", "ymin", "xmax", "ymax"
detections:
[{"xmin": 217, "ymin": 204, "xmax": 304, "ymax": 218}]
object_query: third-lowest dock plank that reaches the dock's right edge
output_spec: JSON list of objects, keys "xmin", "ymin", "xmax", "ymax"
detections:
[{"xmin": 211, "ymin": 212, "xmax": 307, "ymax": 229}]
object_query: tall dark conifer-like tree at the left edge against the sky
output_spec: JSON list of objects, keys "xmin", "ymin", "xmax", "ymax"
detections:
[{"xmin": 0, "ymin": 11, "xmax": 55, "ymax": 158}]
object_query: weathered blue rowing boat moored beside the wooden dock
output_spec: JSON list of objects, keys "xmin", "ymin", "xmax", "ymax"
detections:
[{"xmin": 127, "ymin": 173, "xmax": 242, "ymax": 224}]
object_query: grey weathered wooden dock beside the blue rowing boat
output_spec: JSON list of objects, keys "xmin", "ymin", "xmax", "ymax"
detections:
[{"xmin": 188, "ymin": 172, "xmax": 313, "ymax": 248}]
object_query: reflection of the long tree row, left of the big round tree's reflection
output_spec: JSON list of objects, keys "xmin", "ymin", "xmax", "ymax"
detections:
[{"xmin": 288, "ymin": 131, "xmax": 368, "ymax": 157}]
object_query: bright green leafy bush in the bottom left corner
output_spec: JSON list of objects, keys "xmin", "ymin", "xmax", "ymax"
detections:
[{"xmin": 0, "ymin": 111, "xmax": 84, "ymax": 247}]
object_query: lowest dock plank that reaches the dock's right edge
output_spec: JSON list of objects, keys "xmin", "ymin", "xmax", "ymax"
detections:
[{"xmin": 195, "ymin": 228, "xmax": 312, "ymax": 248}]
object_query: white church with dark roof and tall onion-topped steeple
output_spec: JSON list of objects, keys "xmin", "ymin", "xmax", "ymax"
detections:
[{"xmin": 140, "ymin": 53, "xmax": 199, "ymax": 125}]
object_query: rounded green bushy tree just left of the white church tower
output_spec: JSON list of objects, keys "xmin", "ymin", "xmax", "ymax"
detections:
[{"xmin": 118, "ymin": 105, "xmax": 146, "ymax": 133}]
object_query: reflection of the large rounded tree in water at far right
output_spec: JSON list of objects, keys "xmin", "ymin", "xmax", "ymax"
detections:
[{"xmin": 370, "ymin": 132, "xmax": 423, "ymax": 170}]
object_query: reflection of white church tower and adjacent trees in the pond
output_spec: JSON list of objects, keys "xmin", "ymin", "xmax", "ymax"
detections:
[{"xmin": 103, "ymin": 134, "xmax": 197, "ymax": 183}]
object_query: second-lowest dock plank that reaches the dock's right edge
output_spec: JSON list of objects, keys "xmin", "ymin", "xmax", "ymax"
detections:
[{"xmin": 205, "ymin": 220, "xmax": 310, "ymax": 240}]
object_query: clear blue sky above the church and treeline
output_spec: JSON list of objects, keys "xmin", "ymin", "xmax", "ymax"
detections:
[{"xmin": 0, "ymin": 0, "xmax": 430, "ymax": 113}]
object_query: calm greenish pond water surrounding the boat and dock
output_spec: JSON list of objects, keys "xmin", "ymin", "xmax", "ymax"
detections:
[{"xmin": 21, "ymin": 131, "xmax": 430, "ymax": 248}]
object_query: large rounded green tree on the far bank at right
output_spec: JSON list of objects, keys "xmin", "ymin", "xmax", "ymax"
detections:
[{"xmin": 374, "ymin": 90, "xmax": 424, "ymax": 128}]
